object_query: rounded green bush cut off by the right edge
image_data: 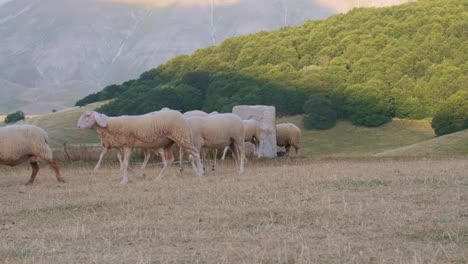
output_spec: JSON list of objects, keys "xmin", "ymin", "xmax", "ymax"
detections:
[{"xmin": 431, "ymin": 91, "xmax": 468, "ymax": 136}]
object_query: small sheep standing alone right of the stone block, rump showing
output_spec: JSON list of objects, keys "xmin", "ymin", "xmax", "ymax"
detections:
[{"xmin": 276, "ymin": 123, "xmax": 301, "ymax": 157}]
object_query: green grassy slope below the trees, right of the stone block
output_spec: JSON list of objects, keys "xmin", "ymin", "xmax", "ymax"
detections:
[{"xmin": 277, "ymin": 116, "xmax": 434, "ymax": 156}]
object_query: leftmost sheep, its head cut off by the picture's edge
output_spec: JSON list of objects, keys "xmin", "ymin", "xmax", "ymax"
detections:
[{"xmin": 0, "ymin": 125, "xmax": 65, "ymax": 185}]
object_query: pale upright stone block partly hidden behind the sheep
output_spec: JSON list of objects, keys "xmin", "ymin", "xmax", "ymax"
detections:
[{"xmin": 232, "ymin": 105, "xmax": 276, "ymax": 158}]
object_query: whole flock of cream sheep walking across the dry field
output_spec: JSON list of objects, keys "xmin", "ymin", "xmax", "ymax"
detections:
[{"xmin": 0, "ymin": 108, "xmax": 301, "ymax": 185}]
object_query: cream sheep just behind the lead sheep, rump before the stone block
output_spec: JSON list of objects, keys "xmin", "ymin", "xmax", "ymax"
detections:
[{"xmin": 182, "ymin": 113, "xmax": 245, "ymax": 173}]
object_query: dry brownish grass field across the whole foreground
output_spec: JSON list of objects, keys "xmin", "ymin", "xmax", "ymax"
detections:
[{"xmin": 0, "ymin": 158, "xmax": 468, "ymax": 263}]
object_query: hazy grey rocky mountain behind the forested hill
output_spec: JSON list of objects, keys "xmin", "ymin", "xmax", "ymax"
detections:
[{"xmin": 0, "ymin": 0, "xmax": 410, "ymax": 114}]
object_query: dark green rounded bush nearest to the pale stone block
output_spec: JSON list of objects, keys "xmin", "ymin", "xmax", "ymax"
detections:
[{"xmin": 303, "ymin": 95, "xmax": 337, "ymax": 129}]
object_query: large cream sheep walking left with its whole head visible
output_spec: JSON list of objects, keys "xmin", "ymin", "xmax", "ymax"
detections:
[{"xmin": 77, "ymin": 110, "xmax": 203, "ymax": 184}]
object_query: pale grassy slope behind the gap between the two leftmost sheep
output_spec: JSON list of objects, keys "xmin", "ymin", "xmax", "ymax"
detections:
[{"xmin": 17, "ymin": 103, "xmax": 103, "ymax": 148}]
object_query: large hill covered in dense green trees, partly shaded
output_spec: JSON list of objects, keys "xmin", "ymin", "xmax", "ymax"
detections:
[{"xmin": 77, "ymin": 0, "xmax": 468, "ymax": 131}]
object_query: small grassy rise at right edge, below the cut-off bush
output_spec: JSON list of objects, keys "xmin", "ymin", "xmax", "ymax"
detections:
[{"xmin": 376, "ymin": 130, "xmax": 468, "ymax": 157}]
